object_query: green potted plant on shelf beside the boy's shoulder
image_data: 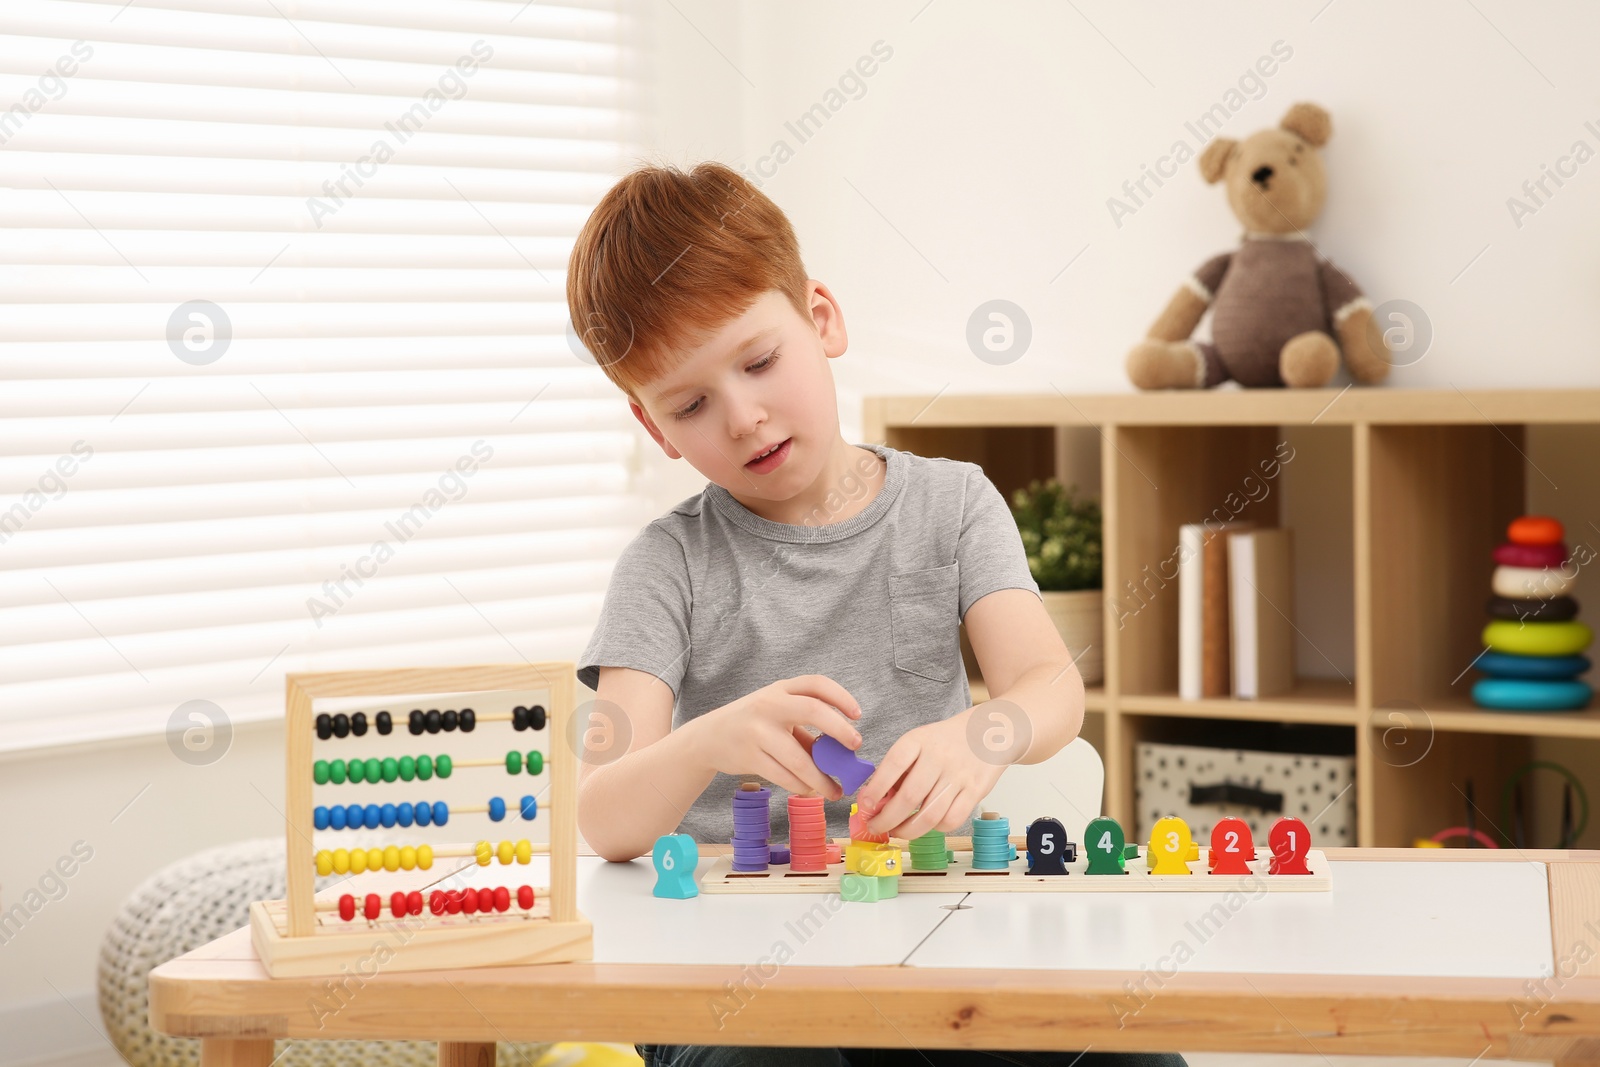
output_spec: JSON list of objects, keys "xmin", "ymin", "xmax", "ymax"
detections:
[{"xmin": 1011, "ymin": 478, "xmax": 1106, "ymax": 685}]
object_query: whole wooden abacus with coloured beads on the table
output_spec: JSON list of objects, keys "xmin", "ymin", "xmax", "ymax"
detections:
[{"xmin": 250, "ymin": 662, "xmax": 594, "ymax": 977}]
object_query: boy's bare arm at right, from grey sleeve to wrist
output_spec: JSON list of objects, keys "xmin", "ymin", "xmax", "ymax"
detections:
[{"xmin": 966, "ymin": 589, "xmax": 1083, "ymax": 763}]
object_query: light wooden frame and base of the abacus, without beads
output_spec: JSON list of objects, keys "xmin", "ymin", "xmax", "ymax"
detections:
[{"xmin": 250, "ymin": 662, "xmax": 594, "ymax": 977}]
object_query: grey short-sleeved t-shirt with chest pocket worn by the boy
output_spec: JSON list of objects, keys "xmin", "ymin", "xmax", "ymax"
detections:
[{"xmin": 578, "ymin": 445, "xmax": 1038, "ymax": 843}]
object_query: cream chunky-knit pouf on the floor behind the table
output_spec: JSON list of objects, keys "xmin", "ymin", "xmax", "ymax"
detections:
[{"xmin": 99, "ymin": 837, "xmax": 550, "ymax": 1067}]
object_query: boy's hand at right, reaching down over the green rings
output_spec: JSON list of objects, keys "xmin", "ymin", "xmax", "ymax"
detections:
[{"xmin": 856, "ymin": 715, "xmax": 1006, "ymax": 841}]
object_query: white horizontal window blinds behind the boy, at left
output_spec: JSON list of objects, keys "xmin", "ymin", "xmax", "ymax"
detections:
[{"xmin": 0, "ymin": 0, "xmax": 650, "ymax": 749}]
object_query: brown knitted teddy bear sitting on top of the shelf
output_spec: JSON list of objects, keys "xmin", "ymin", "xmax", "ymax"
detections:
[{"xmin": 1128, "ymin": 104, "xmax": 1389, "ymax": 389}]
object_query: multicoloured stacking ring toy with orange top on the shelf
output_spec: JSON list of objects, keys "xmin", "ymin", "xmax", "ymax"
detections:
[{"xmin": 1472, "ymin": 515, "xmax": 1594, "ymax": 712}]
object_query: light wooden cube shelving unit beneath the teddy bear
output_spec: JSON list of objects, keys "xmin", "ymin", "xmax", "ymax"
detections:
[{"xmin": 862, "ymin": 389, "xmax": 1600, "ymax": 846}]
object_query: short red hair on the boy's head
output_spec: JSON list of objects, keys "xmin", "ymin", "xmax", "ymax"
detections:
[{"xmin": 566, "ymin": 162, "xmax": 811, "ymax": 402}]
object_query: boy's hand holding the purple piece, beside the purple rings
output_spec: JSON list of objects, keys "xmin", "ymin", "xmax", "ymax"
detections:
[{"xmin": 686, "ymin": 675, "xmax": 861, "ymax": 800}]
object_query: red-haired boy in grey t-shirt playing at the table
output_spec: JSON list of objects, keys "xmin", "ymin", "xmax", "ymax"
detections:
[{"xmin": 566, "ymin": 163, "xmax": 1182, "ymax": 1067}]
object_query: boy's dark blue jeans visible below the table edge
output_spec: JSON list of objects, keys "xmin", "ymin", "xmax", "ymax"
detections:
[{"xmin": 634, "ymin": 1045, "xmax": 1186, "ymax": 1067}]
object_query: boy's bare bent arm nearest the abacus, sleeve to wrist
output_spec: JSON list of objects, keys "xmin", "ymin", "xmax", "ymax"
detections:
[{"xmin": 576, "ymin": 667, "xmax": 717, "ymax": 862}]
